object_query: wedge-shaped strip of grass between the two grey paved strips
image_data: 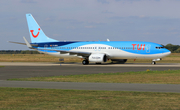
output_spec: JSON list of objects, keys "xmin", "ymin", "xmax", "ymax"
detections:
[{"xmin": 9, "ymin": 70, "xmax": 180, "ymax": 84}]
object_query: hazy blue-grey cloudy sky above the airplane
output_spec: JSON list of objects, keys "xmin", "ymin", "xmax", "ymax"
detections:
[{"xmin": 0, "ymin": 0, "xmax": 180, "ymax": 50}]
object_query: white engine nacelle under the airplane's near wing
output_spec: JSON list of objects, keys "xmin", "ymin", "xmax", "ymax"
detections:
[{"xmin": 89, "ymin": 53, "xmax": 107, "ymax": 62}]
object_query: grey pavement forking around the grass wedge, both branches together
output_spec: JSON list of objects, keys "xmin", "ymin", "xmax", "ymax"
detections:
[{"xmin": 0, "ymin": 62, "xmax": 180, "ymax": 93}]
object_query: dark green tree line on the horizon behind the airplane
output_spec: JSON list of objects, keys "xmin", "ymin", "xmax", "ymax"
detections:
[{"xmin": 0, "ymin": 44, "xmax": 180, "ymax": 54}]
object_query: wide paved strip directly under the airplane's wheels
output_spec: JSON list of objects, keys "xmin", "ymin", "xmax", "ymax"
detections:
[{"xmin": 0, "ymin": 62, "xmax": 180, "ymax": 80}]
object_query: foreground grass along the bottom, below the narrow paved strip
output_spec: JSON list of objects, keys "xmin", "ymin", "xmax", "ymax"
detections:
[{"xmin": 0, "ymin": 88, "xmax": 180, "ymax": 110}]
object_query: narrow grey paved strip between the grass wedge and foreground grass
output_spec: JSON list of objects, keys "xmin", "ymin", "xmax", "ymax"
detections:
[{"xmin": 0, "ymin": 80, "xmax": 180, "ymax": 93}]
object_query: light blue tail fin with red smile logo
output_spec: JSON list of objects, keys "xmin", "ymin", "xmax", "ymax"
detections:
[{"xmin": 26, "ymin": 14, "xmax": 57, "ymax": 43}]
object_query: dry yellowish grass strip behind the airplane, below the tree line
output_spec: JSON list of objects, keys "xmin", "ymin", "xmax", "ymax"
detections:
[{"xmin": 0, "ymin": 53, "xmax": 180, "ymax": 63}]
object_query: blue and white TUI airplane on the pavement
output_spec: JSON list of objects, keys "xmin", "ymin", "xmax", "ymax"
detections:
[{"xmin": 10, "ymin": 14, "xmax": 171, "ymax": 65}]
